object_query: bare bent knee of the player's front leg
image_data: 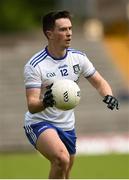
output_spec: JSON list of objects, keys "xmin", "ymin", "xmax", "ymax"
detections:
[{"xmin": 53, "ymin": 152, "xmax": 70, "ymax": 172}]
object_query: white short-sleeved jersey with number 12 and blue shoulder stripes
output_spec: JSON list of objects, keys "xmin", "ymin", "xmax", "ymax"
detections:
[{"xmin": 24, "ymin": 48, "xmax": 95, "ymax": 131}]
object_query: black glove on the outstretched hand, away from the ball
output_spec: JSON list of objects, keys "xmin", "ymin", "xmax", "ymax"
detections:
[{"xmin": 103, "ymin": 95, "xmax": 119, "ymax": 110}]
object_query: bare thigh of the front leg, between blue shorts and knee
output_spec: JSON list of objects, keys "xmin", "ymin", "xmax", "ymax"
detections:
[{"xmin": 36, "ymin": 129, "xmax": 69, "ymax": 161}]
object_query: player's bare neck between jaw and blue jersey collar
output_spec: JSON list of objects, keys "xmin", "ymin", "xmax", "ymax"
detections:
[{"xmin": 47, "ymin": 44, "xmax": 66, "ymax": 59}]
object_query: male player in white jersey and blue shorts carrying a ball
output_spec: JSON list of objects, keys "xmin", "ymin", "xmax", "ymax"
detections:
[{"xmin": 24, "ymin": 11, "xmax": 118, "ymax": 179}]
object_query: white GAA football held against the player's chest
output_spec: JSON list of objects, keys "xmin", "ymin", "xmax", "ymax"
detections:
[{"xmin": 52, "ymin": 79, "xmax": 80, "ymax": 110}]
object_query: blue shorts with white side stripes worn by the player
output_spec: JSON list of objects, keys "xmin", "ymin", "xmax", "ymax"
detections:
[{"xmin": 24, "ymin": 121, "xmax": 77, "ymax": 154}]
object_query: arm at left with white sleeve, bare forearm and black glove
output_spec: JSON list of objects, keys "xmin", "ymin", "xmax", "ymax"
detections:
[{"xmin": 24, "ymin": 65, "xmax": 54, "ymax": 113}]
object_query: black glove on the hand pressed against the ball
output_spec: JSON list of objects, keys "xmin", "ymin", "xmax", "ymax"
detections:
[{"xmin": 43, "ymin": 84, "xmax": 55, "ymax": 108}]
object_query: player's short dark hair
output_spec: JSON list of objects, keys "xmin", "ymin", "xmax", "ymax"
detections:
[{"xmin": 42, "ymin": 11, "xmax": 72, "ymax": 36}]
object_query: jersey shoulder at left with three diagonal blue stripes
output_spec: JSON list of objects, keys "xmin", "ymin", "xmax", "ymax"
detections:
[{"xmin": 25, "ymin": 49, "xmax": 47, "ymax": 68}]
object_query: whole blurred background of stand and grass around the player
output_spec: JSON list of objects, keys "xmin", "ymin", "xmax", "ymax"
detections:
[{"xmin": 0, "ymin": 0, "xmax": 129, "ymax": 179}]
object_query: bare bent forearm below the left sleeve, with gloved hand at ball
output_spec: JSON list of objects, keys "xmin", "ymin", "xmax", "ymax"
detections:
[{"xmin": 26, "ymin": 88, "xmax": 54, "ymax": 114}]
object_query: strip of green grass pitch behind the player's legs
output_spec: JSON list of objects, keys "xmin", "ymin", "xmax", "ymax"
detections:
[{"xmin": 0, "ymin": 153, "xmax": 129, "ymax": 179}]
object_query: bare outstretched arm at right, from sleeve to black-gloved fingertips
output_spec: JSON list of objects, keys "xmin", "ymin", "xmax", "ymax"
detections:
[{"xmin": 87, "ymin": 71, "xmax": 118, "ymax": 110}]
